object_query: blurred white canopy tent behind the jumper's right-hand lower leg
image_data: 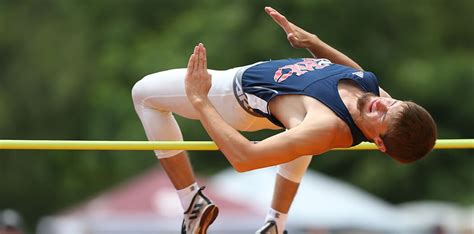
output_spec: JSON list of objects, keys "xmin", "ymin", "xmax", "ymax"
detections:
[{"xmin": 211, "ymin": 168, "xmax": 412, "ymax": 232}]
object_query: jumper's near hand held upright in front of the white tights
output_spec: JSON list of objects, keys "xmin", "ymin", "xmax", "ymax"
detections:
[{"xmin": 184, "ymin": 43, "xmax": 212, "ymax": 105}]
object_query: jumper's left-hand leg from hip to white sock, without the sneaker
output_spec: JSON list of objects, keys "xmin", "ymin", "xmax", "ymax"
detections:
[{"xmin": 132, "ymin": 68, "xmax": 276, "ymax": 207}]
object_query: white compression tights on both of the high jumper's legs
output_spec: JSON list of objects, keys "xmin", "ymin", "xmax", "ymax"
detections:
[{"xmin": 132, "ymin": 68, "xmax": 311, "ymax": 183}]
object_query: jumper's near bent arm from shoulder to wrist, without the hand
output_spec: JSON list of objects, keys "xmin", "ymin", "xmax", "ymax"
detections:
[{"xmin": 194, "ymin": 100, "xmax": 331, "ymax": 172}]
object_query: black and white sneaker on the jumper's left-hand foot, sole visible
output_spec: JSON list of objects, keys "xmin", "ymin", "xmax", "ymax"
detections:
[{"xmin": 181, "ymin": 186, "xmax": 219, "ymax": 234}]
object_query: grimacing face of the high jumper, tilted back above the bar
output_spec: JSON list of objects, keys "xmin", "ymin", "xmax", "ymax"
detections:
[{"xmin": 357, "ymin": 93, "xmax": 404, "ymax": 137}]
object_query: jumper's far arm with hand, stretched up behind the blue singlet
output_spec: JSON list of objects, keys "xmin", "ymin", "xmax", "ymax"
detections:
[{"xmin": 265, "ymin": 7, "xmax": 363, "ymax": 70}]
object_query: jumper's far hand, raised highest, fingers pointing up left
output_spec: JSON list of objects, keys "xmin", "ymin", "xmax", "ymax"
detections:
[{"xmin": 265, "ymin": 7, "xmax": 318, "ymax": 48}]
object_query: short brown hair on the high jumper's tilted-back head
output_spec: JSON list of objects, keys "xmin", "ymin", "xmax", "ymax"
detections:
[{"xmin": 381, "ymin": 101, "xmax": 438, "ymax": 163}]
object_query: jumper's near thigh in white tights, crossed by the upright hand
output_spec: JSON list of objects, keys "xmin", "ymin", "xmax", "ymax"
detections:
[{"xmin": 136, "ymin": 68, "xmax": 276, "ymax": 131}]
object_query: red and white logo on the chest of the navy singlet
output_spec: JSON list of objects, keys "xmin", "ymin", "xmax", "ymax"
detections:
[{"xmin": 273, "ymin": 58, "xmax": 332, "ymax": 83}]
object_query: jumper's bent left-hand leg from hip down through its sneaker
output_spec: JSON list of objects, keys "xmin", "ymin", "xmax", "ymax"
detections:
[{"xmin": 132, "ymin": 66, "xmax": 262, "ymax": 233}]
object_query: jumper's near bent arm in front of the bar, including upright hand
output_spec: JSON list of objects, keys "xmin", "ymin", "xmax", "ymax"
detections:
[{"xmin": 185, "ymin": 44, "xmax": 332, "ymax": 172}]
